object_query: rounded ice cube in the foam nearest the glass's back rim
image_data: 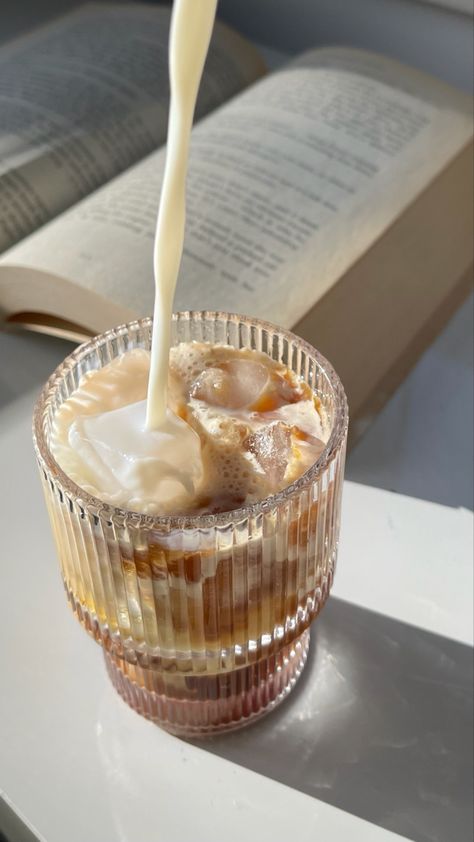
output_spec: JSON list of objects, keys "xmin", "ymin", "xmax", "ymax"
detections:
[{"xmin": 191, "ymin": 359, "xmax": 268, "ymax": 409}]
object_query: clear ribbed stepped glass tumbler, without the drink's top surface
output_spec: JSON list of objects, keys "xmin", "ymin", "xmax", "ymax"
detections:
[{"xmin": 33, "ymin": 311, "xmax": 348, "ymax": 736}]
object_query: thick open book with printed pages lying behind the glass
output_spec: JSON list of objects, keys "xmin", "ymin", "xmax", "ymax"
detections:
[{"xmin": 0, "ymin": 4, "xmax": 473, "ymax": 434}]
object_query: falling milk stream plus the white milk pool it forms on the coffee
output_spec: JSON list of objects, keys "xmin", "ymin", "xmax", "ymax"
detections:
[{"xmin": 52, "ymin": 0, "xmax": 217, "ymax": 511}]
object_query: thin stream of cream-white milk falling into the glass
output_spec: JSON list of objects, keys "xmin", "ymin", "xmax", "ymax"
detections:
[{"xmin": 146, "ymin": 0, "xmax": 217, "ymax": 426}]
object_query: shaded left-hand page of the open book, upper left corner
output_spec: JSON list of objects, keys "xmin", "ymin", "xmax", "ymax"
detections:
[{"xmin": 0, "ymin": 4, "xmax": 262, "ymax": 251}]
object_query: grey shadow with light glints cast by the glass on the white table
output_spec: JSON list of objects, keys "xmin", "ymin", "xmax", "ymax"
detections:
[{"xmin": 194, "ymin": 598, "xmax": 473, "ymax": 842}]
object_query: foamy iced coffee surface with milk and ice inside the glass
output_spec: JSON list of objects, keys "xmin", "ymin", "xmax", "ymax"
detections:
[{"xmin": 51, "ymin": 343, "xmax": 328, "ymax": 514}]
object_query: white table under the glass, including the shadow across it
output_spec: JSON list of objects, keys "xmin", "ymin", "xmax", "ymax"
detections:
[{"xmin": 0, "ymin": 326, "xmax": 472, "ymax": 842}]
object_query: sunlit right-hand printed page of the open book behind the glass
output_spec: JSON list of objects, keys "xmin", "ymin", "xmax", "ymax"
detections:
[{"xmin": 0, "ymin": 49, "xmax": 472, "ymax": 330}]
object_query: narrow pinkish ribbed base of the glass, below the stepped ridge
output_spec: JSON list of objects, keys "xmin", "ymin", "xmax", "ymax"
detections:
[{"xmin": 103, "ymin": 629, "xmax": 309, "ymax": 737}]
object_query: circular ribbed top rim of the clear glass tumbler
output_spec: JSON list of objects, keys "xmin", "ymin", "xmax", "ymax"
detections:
[{"xmin": 33, "ymin": 310, "xmax": 349, "ymax": 532}]
